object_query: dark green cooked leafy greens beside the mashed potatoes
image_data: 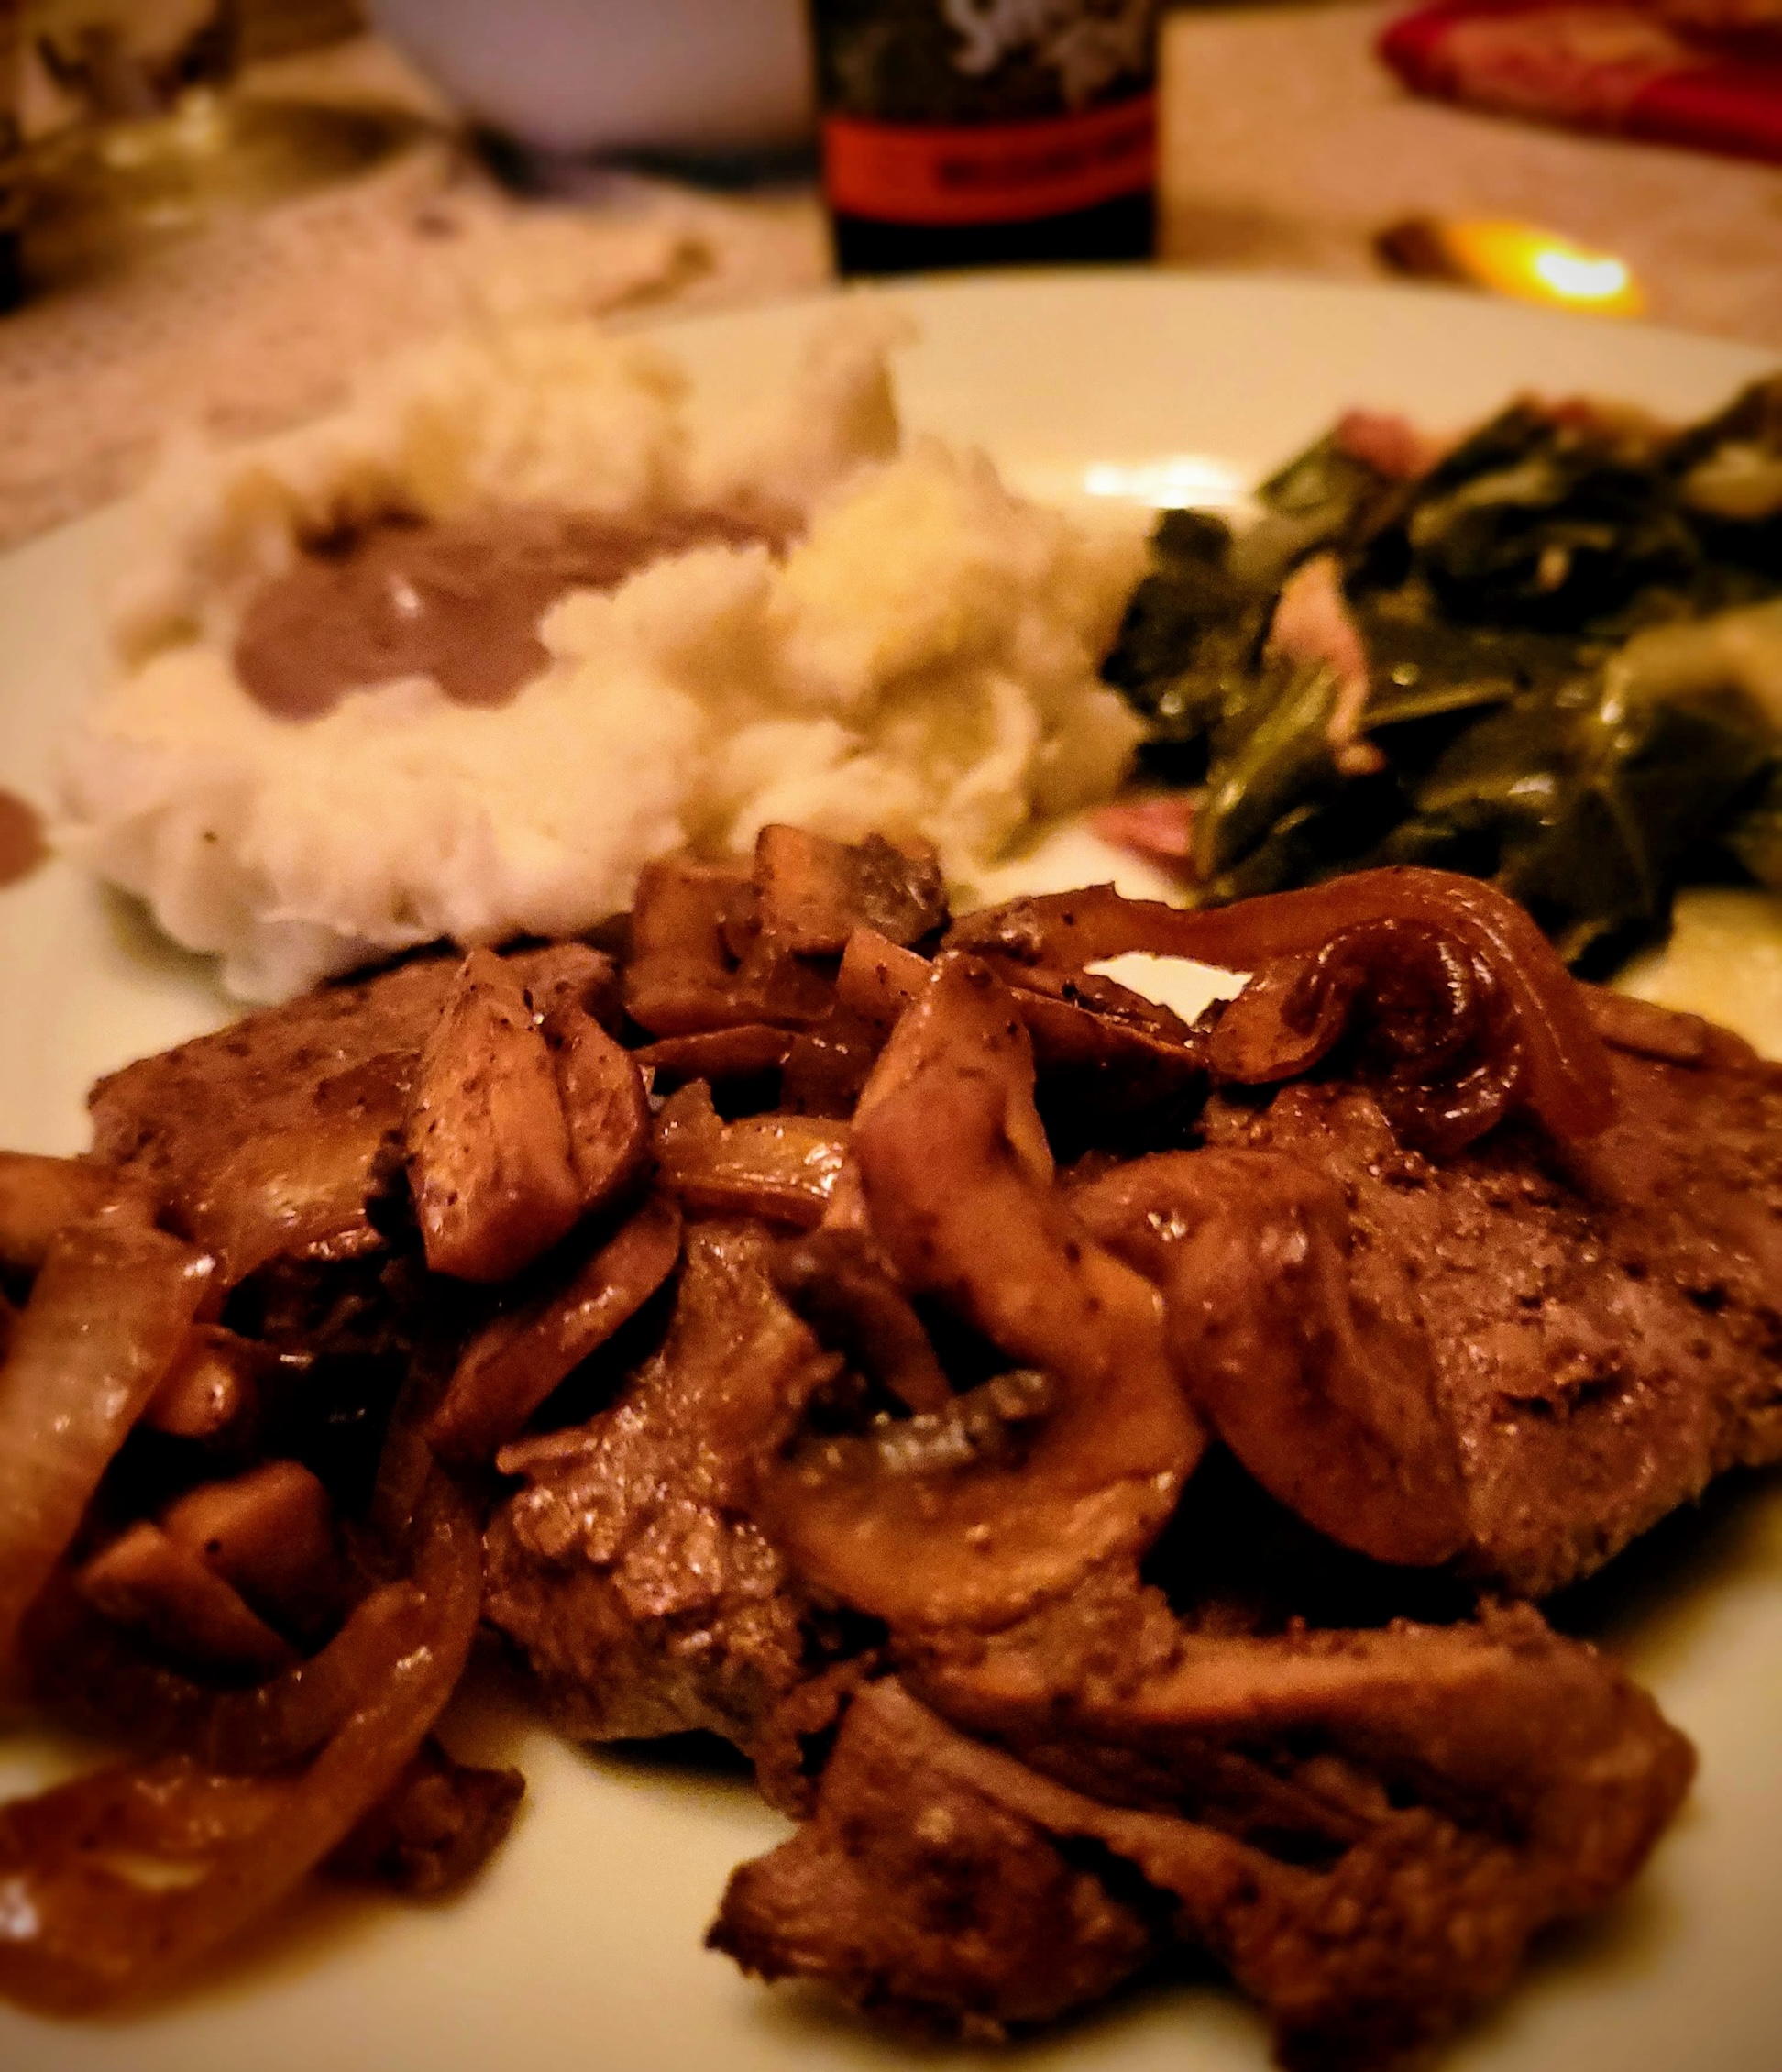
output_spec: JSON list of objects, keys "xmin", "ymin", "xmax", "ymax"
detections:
[{"xmin": 1105, "ymin": 377, "xmax": 1782, "ymax": 970}]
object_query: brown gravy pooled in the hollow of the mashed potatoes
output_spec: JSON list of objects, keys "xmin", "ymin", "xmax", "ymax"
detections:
[{"xmin": 234, "ymin": 503, "xmax": 764, "ymax": 719}]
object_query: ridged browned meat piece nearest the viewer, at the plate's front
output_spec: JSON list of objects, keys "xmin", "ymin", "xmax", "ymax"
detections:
[{"xmin": 713, "ymin": 1574, "xmax": 1693, "ymax": 2067}]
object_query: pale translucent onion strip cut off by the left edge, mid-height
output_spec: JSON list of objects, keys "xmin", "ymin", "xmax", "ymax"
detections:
[{"xmin": 0, "ymin": 1222, "xmax": 215, "ymax": 1662}]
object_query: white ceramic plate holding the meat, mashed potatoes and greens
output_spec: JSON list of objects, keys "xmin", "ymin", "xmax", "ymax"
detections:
[{"xmin": 0, "ymin": 273, "xmax": 1782, "ymax": 2072}]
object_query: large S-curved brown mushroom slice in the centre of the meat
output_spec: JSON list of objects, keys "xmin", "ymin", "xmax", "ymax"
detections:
[{"xmin": 758, "ymin": 957, "xmax": 1202, "ymax": 1626}]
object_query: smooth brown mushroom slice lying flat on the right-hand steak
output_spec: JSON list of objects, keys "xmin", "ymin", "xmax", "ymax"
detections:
[{"xmin": 1072, "ymin": 1150, "xmax": 1467, "ymax": 1567}]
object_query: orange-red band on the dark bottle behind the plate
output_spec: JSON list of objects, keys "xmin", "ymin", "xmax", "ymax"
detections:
[{"xmin": 822, "ymin": 94, "xmax": 1156, "ymax": 224}]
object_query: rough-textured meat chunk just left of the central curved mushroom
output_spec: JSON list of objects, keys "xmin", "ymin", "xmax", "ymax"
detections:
[{"xmin": 485, "ymin": 1225, "xmax": 837, "ymax": 1748}]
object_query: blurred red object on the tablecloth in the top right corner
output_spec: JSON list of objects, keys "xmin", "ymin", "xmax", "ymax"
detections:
[{"xmin": 1380, "ymin": 0, "xmax": 1782, "ymax": 164}]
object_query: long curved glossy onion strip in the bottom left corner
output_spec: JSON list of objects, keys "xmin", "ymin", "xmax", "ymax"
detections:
[{"xmin": 0, "ymin": 1480, "xmax": 483, "ymax": 2014}]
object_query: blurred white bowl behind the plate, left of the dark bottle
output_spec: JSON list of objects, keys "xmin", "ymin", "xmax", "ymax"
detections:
[{"xmin": 371, "ymin": 0, "xmax": 812, "ymax": 153}]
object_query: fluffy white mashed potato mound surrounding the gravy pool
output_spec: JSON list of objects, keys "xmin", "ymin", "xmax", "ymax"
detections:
[{"xmin": 60, "ymin": 309, "xmax": 1142, "ymax": 998}]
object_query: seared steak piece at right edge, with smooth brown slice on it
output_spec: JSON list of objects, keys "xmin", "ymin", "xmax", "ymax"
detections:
[{"xmin": 1077, "ymin": 1009, "xmax": 1782, "ymax": 1597}]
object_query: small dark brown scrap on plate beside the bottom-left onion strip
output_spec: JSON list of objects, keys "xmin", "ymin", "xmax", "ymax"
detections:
[{"xmin": 324, "ymin": 1735, "xmax": 526, "ymax": 1900}]
